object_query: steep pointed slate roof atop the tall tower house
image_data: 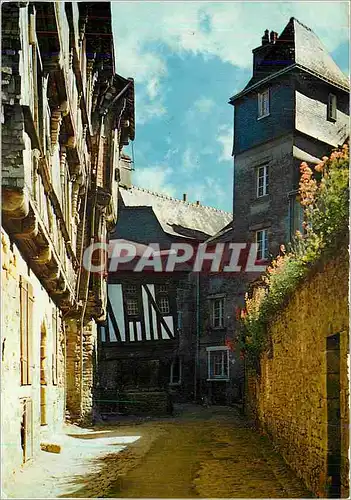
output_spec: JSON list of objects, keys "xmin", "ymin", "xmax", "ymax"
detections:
[{"xmin": 230, "ymin": 17, "xmax": 349, "ymax": 102}]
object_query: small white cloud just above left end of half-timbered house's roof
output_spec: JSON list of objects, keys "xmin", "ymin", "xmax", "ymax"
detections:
[{"xmin": 135, "ymin": 165, "xmax": 176, "ymax": 196}]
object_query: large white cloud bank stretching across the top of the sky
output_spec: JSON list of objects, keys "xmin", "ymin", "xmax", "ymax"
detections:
[{"xmin": 112, "ymin": 1, "xmax": 349, "ymax": 123}]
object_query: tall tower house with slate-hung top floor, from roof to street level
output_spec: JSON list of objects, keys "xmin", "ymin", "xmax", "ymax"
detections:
[{"xmin": 194, "ymin": 18, "xmax": 349, "ymax": 402}]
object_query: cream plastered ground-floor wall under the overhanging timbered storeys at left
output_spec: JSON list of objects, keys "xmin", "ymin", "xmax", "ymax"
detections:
[{"xmin": 1, "ymin": 231, "xmax": 65, "ymax": 491}]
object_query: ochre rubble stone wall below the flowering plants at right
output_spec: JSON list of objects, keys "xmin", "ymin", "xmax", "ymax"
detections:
[{"xmin": 246, "ymin": 252, "xmax": 349, "ymax": 496}]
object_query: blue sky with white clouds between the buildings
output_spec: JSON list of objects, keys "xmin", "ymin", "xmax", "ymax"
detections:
[{"xmin": 112, "ymin": 1, "xmax": 349, "ymax": 211}]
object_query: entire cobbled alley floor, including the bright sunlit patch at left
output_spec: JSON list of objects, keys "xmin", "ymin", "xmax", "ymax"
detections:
[{"xmin": 9, "ymin": 405, "xmax": 311, "ymax": 498}]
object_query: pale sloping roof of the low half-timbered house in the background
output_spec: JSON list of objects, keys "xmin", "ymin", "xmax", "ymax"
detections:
[{"xmin": 120, "ymin": 186, "xmax": 233, "ymax": 240}]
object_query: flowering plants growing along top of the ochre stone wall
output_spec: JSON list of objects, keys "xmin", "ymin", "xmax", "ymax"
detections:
[{"xmin": 239, "ymin": 144, "xmax": 349, "ymax": 365}]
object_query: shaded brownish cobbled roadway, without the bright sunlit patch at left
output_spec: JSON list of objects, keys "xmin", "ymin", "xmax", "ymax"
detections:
[{"xmin": 104, "ymin": 406, "xmax": 311, "ymax": 498}]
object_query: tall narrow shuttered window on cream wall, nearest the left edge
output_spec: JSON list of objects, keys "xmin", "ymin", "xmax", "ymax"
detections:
[{"xmin": 20, "ymin": 276, "xmax": 34, "ymax": 385}]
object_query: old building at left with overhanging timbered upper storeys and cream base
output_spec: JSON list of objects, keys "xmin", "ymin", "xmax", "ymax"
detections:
[{"xmin": 1, "ymin": 2, "xmax": 134, "ymax": 489}]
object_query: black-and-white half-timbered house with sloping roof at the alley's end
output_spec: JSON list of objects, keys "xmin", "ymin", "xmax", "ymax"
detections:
[{"xmin": 98, "ymin": 187, "xmax": 231, "ymax": 412}]
